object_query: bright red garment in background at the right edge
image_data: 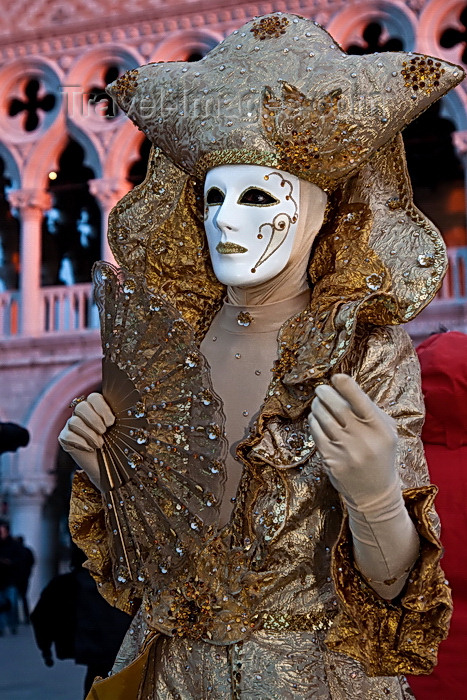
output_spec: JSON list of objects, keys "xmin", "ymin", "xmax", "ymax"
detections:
[{"xmin": 408, "ymin": 331, "xmax": 467, "ymax": 700}]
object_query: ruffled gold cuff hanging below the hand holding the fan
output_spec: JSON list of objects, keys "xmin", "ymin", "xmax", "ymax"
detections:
[{"xmin": 69, "ymin": 471, "xmax": 140, "ymax": 615}]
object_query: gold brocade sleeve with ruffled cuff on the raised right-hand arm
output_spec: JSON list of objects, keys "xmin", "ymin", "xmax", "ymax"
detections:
[{"xmin": 327, "ymin": 327, "xmax": 452, "ymax": 675}]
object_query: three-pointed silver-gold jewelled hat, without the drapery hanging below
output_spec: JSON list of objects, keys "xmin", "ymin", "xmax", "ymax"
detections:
[{"xmin": 108, "ymin": 13, "xmax": 464, "ymax": 189}]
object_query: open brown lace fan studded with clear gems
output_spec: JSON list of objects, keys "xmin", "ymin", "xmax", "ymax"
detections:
[{"xmin": 93, "ymin": 262, "xmax": 227, "ymax": 585}]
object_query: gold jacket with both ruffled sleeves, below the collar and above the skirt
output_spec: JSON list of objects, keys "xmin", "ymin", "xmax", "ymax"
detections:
[{"xmin": 71, "ymin": 318, "xmax": 449, "ymax": 675}]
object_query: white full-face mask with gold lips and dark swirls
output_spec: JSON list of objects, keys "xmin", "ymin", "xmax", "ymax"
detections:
[{"xmin": 204, "ymin": 165, "xmax": 300, "ymax": 287}]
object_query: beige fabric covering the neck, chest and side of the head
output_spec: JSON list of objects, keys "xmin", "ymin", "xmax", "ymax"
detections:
[{"xmin": 201, "ymin": 180, "xmax": 326, "ymax": 523}]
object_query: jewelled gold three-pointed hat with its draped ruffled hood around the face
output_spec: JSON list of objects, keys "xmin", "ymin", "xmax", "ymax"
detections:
[{"xmin": 105, "ymin": 12, "xmax": 464, "ymax": 382}]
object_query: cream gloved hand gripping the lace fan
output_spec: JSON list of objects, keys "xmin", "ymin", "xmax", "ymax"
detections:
[{"xmin": 58, "ymin": 393, "xmax": 115, "ymax": 488}]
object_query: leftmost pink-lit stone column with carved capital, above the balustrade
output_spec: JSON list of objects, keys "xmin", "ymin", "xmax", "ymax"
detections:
[{"xmin": 8, "ymin": 189, "xmax": 52, "ymax": 336}]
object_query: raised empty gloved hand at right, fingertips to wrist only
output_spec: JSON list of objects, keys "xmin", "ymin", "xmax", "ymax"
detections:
[{"xmin": 309, "ymin": 374, "xmax": 401, "ymax": 512}]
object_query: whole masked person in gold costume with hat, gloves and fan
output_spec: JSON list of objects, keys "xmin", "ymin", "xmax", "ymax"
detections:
[{"xmin": 60, "ymin": 13, "xmax": 463, "ymax": 700}]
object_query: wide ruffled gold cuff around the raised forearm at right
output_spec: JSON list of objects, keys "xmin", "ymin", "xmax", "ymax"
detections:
[{"xmin": 326, "ymin": 486, "xmax": 452, "ymax": 676}]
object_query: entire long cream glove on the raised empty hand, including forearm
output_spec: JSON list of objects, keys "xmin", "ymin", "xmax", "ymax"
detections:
[{"xmin": 309, "ymin": 374, "xmax": 419, "ymax": 600}]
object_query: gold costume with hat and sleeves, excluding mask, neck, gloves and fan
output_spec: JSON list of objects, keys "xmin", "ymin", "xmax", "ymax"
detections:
[{"xmin": 70, "ymin": 13, "xmax": 462, "ymax": 700}]
